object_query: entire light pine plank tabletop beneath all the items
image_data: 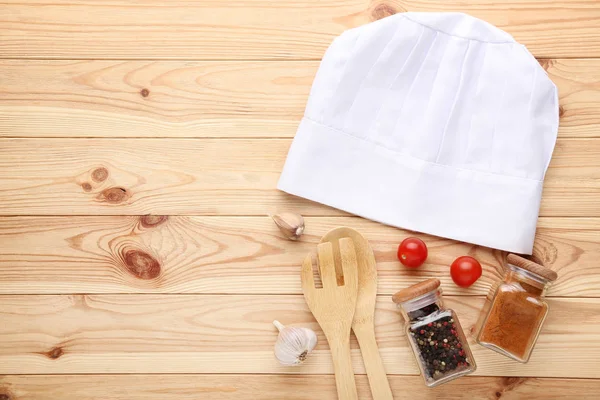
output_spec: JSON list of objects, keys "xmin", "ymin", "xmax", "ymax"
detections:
[{"xmin": 0, "ymin": 0, "xmax": 600, "ymax": 400}]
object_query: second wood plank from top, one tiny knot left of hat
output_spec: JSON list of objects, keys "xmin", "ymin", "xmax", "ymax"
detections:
[{"xmin": 0, "ymin": 59, "xmax": 600, "ymax": 138}]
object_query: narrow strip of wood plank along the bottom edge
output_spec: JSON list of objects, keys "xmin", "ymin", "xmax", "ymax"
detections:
[{"xmin": 0, "ymin": 374, "xmax": 600, "ymax": 400}]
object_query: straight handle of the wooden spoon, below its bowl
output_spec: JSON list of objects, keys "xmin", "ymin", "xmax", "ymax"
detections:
[{"xmin": 354, "ymin": 325, "xmax": 393, "ymax": 400}]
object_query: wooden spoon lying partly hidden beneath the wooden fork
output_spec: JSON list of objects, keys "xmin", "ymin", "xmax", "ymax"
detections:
[{"xmin": 319, "ymin": 227, "xmax": 393, "ymax": 400}]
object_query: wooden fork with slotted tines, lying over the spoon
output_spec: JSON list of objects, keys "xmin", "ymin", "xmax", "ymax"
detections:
[{"xmin": 302, "ymin": 239, "xmax": 358, "ymax": 400}]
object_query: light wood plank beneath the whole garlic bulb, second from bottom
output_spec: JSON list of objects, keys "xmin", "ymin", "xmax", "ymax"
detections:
[{"xmin": 0, "ymin": 295, "xmax": 600, "ymax": 378}]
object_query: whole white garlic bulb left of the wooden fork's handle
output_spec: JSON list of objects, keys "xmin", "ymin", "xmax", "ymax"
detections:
[{"xmin": 273, "ymin": 321, "xmax": 317, "ymax": 366}]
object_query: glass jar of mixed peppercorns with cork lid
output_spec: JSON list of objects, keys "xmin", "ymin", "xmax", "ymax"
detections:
[{"xmin": 392, "ymin": 279, "xmax": 476, "ymax": 387}]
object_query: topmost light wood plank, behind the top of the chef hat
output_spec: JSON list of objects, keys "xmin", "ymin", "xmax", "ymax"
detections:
[{"xmin": 0, "ymin": 0, "xmax": 600, "ymax": 59}]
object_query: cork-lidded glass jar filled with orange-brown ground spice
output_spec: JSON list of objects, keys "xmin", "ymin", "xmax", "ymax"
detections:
[{"xmin": 477, "ymin": 254, "xmax": 558, "ymax": 363}]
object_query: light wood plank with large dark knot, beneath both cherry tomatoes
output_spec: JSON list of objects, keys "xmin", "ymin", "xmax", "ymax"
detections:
[{"xmin": 0, "ymin": 216, "xmax": 600, "ymax": 297}]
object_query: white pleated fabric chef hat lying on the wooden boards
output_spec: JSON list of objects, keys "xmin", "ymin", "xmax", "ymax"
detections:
[{"xmin": 278, "ymin": 12, "xmax": 558, "ymax": 254}]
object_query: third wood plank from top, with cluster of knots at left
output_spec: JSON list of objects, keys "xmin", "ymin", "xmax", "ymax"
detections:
[{"xmin": 0, "ymin": 139, "xmax": 600, "ymax": 217}]
